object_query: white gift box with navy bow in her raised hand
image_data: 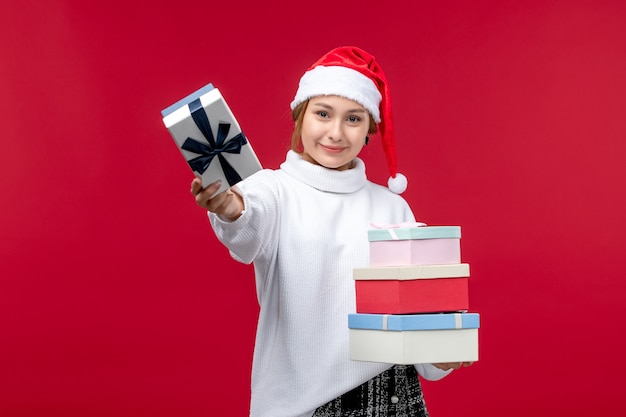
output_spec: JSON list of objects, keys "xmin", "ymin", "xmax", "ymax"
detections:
[{"xmin": 161, "ymin": 84, "xmax": 262, "ymax": 195}]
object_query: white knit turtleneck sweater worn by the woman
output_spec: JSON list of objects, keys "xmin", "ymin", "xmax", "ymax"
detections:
[{"xmin": 209, "ymin": 151, "xmax": 449, "ymax": 417}]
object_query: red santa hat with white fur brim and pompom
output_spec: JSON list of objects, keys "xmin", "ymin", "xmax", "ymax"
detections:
[{"xmin": 291, "ymin": 46, "xmax": 407, "ymax": 194}]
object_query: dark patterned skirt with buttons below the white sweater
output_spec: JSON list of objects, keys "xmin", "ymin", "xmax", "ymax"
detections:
[{"xmin": 313, "ymin": 365, "xmax": 428, "ymax": 417}]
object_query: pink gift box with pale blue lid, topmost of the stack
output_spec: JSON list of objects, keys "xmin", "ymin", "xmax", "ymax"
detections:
[{"xmin": 368, "ymin": 226, "xmax": 461, "ymax": 266}]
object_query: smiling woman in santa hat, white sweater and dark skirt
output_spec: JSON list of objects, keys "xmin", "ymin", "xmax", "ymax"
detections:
[{"xmin": 191, "ymin": 47, "xmax": 468, "ymax": 417}]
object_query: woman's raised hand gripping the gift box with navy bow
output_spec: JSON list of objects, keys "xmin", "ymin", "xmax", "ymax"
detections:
[{"xmin": 191, "ymin": 178, "xmax": 244, "ymax": 221}]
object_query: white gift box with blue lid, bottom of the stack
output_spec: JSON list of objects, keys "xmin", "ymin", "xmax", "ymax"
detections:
[{"xmin": 348, "ymin": 313, "xmax": 480, "ymax": 365}]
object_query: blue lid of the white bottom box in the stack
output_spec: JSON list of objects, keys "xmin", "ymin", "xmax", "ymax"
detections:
[{"xmin": 348, "ymin": 313, "xmax": 480, "ymax": 331}]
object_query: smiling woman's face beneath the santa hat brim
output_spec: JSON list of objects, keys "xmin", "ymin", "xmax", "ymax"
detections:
[{"xmin": 301, "ymin": 96, "xmax": 369, "ymax": 170}]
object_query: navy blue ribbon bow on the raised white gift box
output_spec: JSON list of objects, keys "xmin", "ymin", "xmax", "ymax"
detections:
[{"xmin": 182, "ymin": 99, "xmax": 248, "ymax": 185}]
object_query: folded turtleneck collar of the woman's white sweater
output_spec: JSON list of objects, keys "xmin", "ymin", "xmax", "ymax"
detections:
[{"xmin": 280, "ymin": 150, "xmax": 367, "ymax": 193}]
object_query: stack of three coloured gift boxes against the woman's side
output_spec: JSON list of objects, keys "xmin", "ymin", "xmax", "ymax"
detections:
[{"xmin": 348, "ymin": 223, "xmax": 480, "ymax": 364}]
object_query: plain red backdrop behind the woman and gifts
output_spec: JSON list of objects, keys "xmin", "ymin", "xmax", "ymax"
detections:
[{"xmin": 0, "ymin": 0, "xmax": 626, "ymax": 417}]
